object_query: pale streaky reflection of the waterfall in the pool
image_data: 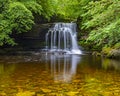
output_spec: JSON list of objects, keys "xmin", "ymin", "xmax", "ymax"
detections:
[{"xmin": 46, "ymin": 54, "xmax": 80, "ymax": 82}]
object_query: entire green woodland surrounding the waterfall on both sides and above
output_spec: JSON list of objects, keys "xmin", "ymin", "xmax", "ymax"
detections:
[{"xmin": 0, "ymin": 0, "xmax": 120, "ymax": 55}]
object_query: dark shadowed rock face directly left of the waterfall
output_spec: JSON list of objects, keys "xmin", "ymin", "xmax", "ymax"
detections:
[{"xmin": 14, "ymin": 23, "xmax": 52, "ymax": 49}]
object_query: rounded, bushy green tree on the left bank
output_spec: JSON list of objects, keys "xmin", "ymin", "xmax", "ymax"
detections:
[{"xmin": 0, "ymin": 2, "xmax": 34, "ymax": 46}]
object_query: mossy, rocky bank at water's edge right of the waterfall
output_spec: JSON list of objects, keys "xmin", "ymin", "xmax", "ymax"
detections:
[{"xmin": 79, "ymin": 41, "xmax": 120, "ymax": 59}]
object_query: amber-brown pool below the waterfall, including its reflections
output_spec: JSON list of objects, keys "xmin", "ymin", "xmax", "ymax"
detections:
[{"xmin": 0, "ymin": 53, "xmax": 120, "ymax": 96}]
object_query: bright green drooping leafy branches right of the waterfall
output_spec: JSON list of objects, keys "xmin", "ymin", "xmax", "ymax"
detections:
[{"xmin": 81, "ymin": 0, "xmax": 120, "ymax": 46}]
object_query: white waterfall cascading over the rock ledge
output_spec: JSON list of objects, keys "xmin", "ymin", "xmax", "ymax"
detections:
[{"xmin": 46, "ymin": 23, "xmax": 82, "ymax": 54}]
